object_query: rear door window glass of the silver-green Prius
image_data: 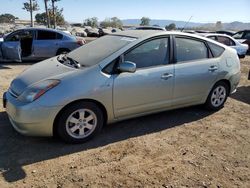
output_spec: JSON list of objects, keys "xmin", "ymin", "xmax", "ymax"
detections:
[{"xmin": 176, "ymin": 38, "xmax": 208, "ymax": 62}]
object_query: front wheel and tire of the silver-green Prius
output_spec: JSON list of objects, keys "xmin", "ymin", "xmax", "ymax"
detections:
[{"xmin": 56, "ymin": 102, "xmax": 104, "ymax": 144}]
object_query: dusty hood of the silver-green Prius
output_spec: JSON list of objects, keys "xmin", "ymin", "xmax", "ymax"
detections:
[{"xmin": 10, "ymin": 57, "xmax": 78, "ymax": 96}]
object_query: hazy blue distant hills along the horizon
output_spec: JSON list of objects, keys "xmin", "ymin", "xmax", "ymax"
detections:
[{"xmin": 122, "ymin": 19, "xmax": 250, "ymax": 30}]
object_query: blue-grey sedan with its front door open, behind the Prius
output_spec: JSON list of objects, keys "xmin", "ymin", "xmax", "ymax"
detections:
[{"xmin": 0, "ymin": 28, "xmax": 84, "ymax": 62}]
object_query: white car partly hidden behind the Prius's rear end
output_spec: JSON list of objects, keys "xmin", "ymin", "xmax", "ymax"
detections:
[{"xmin": 202, "ymin": 33, "xmax": 248, "ymax": 58}]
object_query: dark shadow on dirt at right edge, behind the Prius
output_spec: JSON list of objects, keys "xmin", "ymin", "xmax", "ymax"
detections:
[{"xmin": 230, "ymin": 86, "xmax": 250, "ymax": 105}]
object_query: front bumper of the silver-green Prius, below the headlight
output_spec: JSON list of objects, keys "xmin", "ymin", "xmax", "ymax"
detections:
[{"xmin": 3, "ymin": 92, "xmax": 61, "ymax": 136}]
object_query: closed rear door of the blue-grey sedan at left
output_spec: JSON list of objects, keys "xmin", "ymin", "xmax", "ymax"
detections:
[{"xmin": 33, "ymin": 30, "xmax": 58, "ymax": 58}]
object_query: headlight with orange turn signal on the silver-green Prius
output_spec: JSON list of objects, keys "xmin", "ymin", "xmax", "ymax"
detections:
[{"xmin": 18, "ymin": 80, "xmax": 60, "ymax": 102}]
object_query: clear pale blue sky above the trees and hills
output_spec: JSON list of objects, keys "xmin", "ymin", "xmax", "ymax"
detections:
[{"xmin": 0, "ymin": 0, "xmax": 250, "ymax": 23}]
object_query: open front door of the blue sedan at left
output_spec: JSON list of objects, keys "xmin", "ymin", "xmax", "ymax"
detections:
[{"xmin": 1, "ymin": 30, "xmax": 21, "ymax": 62}]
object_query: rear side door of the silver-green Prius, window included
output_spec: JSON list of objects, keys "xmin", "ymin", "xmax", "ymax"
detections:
[{"xmin": 173, "ymin": 36, "xmax": 219, "ymax": 106}]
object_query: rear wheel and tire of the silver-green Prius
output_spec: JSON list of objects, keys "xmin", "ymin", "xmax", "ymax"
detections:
[{"xmin": 205, "ymin": 81, "xmax": 229, "ymax": 111}]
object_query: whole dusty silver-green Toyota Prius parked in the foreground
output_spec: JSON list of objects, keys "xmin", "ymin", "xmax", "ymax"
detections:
[{"xmin": 3, "ymin": 30, "xmax": 240, "ymax": 143}]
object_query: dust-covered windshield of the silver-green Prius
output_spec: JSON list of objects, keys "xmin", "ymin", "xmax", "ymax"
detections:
[{"xmin": 68, "ymin": 35, "xmax": 136, "ymax": 66}]
